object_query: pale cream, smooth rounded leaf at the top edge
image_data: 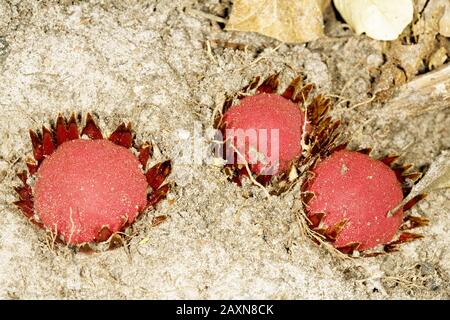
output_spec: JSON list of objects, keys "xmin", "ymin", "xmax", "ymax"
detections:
[{"xmin": 334, "ymin": 0, "xmax": 414, "ymax": 40}]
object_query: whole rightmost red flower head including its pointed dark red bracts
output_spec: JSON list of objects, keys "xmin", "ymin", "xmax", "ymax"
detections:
[{"xmin": 303, "ymin": 149, "xmax": 427, "ymax": 253}]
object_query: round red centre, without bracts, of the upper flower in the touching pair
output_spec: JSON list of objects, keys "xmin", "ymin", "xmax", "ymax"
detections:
[{"xmin": 223, "ymin": 93, "xmax": 304, "ymax": 174}]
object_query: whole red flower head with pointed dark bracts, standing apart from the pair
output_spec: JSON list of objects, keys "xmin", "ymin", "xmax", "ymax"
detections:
[{"xmin": 16, "ymin": 115, "xmax": 170, "ymax": 251}]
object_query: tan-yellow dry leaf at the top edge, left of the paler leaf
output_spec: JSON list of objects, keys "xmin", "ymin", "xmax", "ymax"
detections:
[{"xmin": 226, "ymin": 0, "xmax": 329, "ymax": 43}]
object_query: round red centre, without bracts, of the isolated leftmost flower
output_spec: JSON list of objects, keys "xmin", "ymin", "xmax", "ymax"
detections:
[{"xmin": 34, "ymin": 139, "xmax": 147, "ymax": 244}]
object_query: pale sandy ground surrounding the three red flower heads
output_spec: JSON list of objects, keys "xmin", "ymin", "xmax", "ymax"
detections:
[{"xmin": 0, "ymin": 0, "xmax": 450, "ymax": 299}]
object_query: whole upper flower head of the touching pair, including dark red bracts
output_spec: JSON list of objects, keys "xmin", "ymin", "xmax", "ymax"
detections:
[{"xmin": 216, "ymin": 74, "xmax": 329, "ymax": 185}]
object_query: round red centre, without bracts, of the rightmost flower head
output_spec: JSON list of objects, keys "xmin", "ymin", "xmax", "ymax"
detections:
[{"xmin": 307, "ymin": 150, "xmax": 403, "ymax": 250}]
